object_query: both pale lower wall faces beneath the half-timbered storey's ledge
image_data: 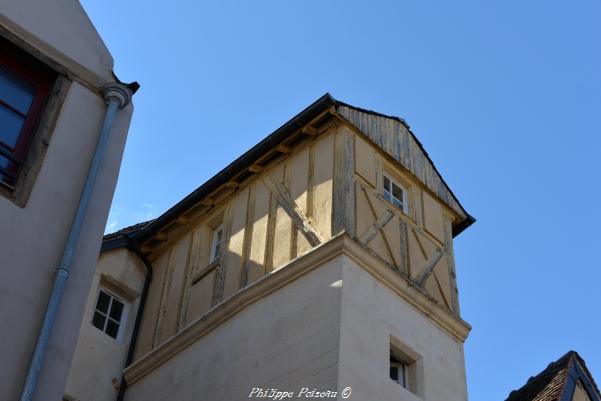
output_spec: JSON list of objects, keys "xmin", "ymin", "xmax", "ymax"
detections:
[{"xmin": 119, "ymin": 247, "xmax": 467, "ymax": 401}]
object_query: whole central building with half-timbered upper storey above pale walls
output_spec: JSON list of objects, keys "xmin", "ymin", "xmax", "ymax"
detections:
[{"xmin": 65, "ymin": 95, "xmax": 474, "ymax": 401}]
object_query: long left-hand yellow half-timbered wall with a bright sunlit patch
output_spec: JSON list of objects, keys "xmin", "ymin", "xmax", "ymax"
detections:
[{"xmin": 136, "ymin": 133, "xmax": 334, "ymax": 357}]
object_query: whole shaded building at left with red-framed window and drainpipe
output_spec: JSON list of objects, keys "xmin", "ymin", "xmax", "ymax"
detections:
[{"xmin": 0, "ymin": 0, "xmax": 136, "ymax": 401}]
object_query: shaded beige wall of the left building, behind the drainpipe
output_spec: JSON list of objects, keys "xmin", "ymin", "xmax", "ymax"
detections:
[{"xmin": 0, "ymin": 83, "xmax": 132, "ymax": 400}]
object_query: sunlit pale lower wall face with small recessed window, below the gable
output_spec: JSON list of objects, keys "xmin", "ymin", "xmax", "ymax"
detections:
[{"xmin": 338, "ymin": 258, "xmax": 467, "ymax": 401}]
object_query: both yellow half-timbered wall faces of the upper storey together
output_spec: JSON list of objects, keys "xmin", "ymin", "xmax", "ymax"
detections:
[{"xmin": 131, "ymin": 127, "xmax": 455, "ymax": 356}]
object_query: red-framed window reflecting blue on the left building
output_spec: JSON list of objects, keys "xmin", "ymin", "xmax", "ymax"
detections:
[{"xmin": 0, "ymin": 40, "xmax": 56, "ymax": 188}]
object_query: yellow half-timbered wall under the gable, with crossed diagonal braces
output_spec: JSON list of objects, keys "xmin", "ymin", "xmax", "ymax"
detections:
[{"xmin": 355, "ymin": 134, "xmax": 455, "ymax": 309}]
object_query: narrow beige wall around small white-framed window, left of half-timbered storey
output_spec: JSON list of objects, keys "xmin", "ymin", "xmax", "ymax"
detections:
[{"xmin": 65, "ymin": 248, "xmax": 146, "ymax": 401}]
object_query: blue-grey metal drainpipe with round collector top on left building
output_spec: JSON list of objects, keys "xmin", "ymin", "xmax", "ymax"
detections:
[{"xmin": 20, "ymin": 82, "xmax": 132, "ymax": 401}]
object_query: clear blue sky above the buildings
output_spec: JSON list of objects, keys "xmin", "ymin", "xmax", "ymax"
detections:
[{"xmin": 82, "ymin": 0, "xmax": 601, "ymax": 401}]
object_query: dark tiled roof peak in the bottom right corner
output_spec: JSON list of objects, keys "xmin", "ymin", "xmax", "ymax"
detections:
[{"xmin": 505, "ymin": 351, "xmax": 600, "ymax": 401}]
